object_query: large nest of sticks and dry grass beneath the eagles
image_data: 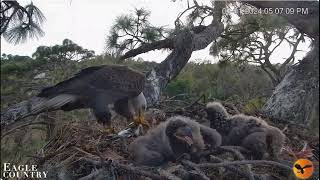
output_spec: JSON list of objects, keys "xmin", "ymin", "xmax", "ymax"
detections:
[{"xmin": 26, "ymin": 100, "xmax": 319, "ymax": 180}]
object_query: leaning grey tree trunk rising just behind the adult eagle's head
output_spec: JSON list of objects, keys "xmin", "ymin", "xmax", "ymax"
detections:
[{"xmin": 144, "ymin": 22, "xmax": 224, "ymax": 106}]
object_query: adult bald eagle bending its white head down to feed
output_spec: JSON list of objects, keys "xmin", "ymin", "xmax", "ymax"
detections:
[{"xmin": 35, "ymin": 65, "xmax": 147, "ymax": 130}]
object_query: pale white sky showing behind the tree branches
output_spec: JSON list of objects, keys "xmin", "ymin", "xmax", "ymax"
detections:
[{"xmin": 1, "ymin": 0, "xmax": 309, "ymax": 63}]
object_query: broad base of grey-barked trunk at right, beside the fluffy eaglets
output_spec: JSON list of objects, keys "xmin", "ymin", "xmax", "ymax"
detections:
[{"xmin": 263, "ymin": 46, "xmax": 319, "ymax": 130}]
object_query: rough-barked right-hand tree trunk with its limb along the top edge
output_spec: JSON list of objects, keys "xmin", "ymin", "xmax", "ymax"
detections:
[{"xmin": 246, "ymin": 1, "xmax": 319, "ymax": 129}]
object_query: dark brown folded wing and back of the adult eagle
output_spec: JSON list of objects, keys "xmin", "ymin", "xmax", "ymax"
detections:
[{"xmin": 38, "ymin": 65, "xmax": 145, "ymax": 101}]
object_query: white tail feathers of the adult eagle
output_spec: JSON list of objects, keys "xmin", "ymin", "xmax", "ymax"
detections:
[{"xmin": 31, "ymin": 94, "xmax": 77, "ymax": 114}]
